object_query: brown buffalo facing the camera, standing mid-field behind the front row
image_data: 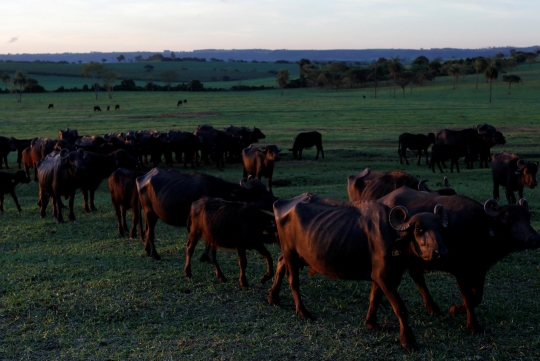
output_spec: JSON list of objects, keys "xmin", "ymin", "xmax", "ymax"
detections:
[{"xmin": 242, "ymin": 145, "xmax": 281, "ymax": 192}]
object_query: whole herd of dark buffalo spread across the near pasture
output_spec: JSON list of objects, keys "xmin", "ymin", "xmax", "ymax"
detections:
[{"xmin": 0, "ymin": 124, "xmax": 540, "ymax": 349}]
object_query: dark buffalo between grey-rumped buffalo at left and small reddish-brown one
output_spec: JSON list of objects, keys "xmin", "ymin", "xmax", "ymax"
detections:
[{"xmin": 80, "ymin": 149, "xmax": 140, "ymax": 212}]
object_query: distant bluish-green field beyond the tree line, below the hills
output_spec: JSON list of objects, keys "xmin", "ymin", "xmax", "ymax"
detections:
[{"xmin": 0, "ymin": 61, "xmax": 299, "ymax": 90}]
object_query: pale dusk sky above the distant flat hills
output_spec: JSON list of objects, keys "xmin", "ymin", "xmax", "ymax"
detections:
[{"xmin": 0, "ymin": 0, "xmax": 540, "ymax": 54}]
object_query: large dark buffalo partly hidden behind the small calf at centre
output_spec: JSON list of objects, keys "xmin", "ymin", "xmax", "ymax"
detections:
[{"xmin": 137, "ymin": 168, "xmax": 277, "ymax": 259}]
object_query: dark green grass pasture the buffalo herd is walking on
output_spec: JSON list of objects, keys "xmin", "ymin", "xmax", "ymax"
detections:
[{"xmin": 0, "ymin": 63, "xmax": 540, "ymax": 360}]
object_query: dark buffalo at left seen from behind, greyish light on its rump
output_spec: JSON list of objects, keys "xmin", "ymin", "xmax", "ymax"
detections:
[{"xmin": 37, "ymin": 149, "xmax": 87, "ymax": 223}]
